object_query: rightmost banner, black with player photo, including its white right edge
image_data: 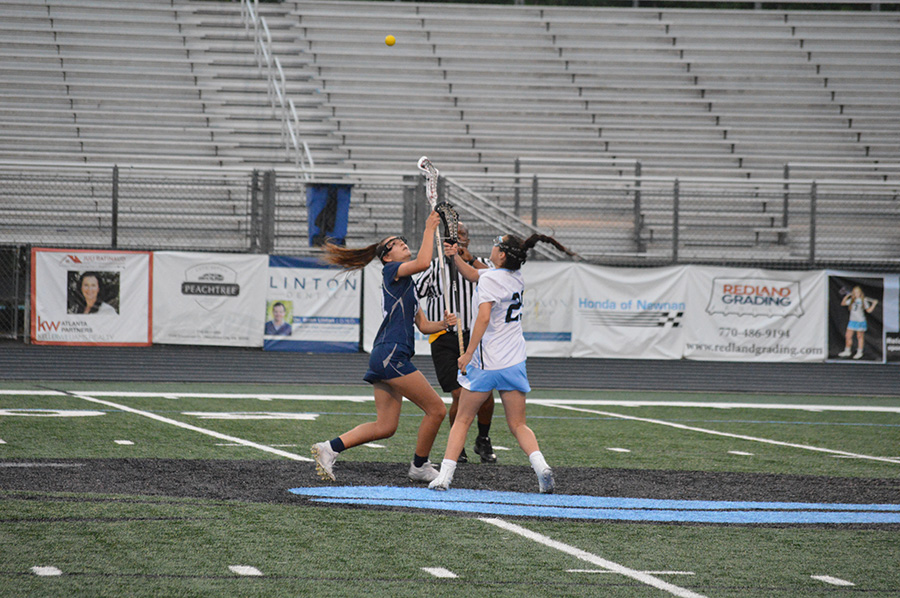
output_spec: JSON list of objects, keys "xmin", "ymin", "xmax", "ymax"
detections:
[{"xmin": 827, "ymin": 271, "xmax": 900, "ymax": 363}]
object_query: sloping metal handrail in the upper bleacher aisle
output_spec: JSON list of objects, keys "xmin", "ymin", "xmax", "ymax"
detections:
[{"xmin": 241, "ymin": 0, "xmax": 315, "ymax": 180}]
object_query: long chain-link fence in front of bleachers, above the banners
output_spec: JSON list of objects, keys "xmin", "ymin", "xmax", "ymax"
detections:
[{"xmin": 0, "ymin": 162, "xmax": 900, "ymax": 269}]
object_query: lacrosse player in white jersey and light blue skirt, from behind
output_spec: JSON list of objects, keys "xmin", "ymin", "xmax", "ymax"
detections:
[{"xmin": 428, "ymin": 235, "xmax": 571, "ymax": 493}]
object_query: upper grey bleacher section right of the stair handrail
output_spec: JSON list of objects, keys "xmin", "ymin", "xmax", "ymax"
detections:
[{"xmin": 284, "ymin": 2, "xmax": 897, "ymax": 177}]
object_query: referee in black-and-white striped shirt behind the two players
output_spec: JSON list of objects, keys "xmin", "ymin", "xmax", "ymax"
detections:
[{"xmin": 416, "ymin": 223, "xmax": 497, "ymax": 463}]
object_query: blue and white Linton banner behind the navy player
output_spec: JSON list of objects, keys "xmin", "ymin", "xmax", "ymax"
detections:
[{"xmin": 263, "ymin": 256, "xmax": 362, "ymax": 353}]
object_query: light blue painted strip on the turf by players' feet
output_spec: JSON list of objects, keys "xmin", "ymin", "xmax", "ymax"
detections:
[{"xmin": 290, "ymin": 486, "xmax": 900, "ymax": 524}]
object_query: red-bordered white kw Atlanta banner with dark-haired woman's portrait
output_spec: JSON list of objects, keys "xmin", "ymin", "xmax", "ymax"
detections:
[{"xmin": 31, "ymin": 248, "xmax": 152, "ymax": 346}]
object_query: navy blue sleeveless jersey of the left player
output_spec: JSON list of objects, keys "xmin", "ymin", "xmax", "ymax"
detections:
[{"xmin": 374, "ymin": 262, "xmax": 419, "ymax": 357}]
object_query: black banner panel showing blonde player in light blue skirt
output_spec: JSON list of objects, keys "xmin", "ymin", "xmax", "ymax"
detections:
[{"xmin": 828, "ymin": 275, "xmax": 884, "ymax": 363}]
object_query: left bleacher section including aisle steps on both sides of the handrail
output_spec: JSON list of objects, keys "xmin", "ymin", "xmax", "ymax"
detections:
[{"xmin": 0, "ymin": 0, "xmax": 341, "ymax": 167}]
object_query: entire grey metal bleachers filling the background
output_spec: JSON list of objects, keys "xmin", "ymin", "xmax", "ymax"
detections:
[{"xmin": 0, "ymin": 0, "xmax": 900, "ymax": 259}]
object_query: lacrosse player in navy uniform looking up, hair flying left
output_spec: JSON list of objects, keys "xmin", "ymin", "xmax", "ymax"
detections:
[{"xmin": 312, "ymin": 212, "xmax": 457, "ymax": 482}]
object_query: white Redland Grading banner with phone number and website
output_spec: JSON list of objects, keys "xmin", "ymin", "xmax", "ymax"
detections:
[{"xmin": 684, "ymin": 266, "xmax": 826, "ymax": 361}]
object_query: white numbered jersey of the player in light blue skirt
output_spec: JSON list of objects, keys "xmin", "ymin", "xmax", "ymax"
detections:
[{"xmin": 471, "ymin": 268, "xmax": 525, "ymax": 370}]
